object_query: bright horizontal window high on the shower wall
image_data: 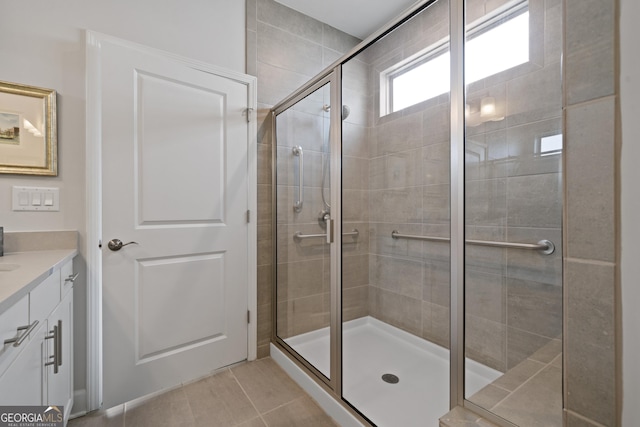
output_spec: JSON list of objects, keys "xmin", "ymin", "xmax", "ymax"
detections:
[{"xmin": 380, "ymin": 2, "xmax": 529, "ymax": 115}]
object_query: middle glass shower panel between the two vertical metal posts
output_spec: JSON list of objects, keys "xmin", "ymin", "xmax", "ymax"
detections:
[{"xmin": 341, "ymin": 0, "xmax": 451, "ymax": 427}]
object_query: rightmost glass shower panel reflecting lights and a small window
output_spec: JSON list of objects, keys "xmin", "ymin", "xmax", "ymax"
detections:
[{"xmin": 465, "ymin": 0, "xmax": 562, "ymax": 426}]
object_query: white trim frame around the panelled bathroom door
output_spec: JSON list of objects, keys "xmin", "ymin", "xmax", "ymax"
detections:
[{"xmin": 85, "ymin": 30, "xmax": 258, "ymax": 412}]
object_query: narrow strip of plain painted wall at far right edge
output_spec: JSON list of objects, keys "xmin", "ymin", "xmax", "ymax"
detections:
[{"xmin": 620, "ymin": 0, "xmax": 640, "ymax": 427}]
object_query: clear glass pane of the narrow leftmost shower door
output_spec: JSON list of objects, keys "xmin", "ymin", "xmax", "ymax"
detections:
[{"xmin": 274, "ymin": 79, "xmax": 331, "ymax": 382}]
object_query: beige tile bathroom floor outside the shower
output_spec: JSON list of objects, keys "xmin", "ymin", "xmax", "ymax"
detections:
[{"xmin": 69, "ymin": 358, "xmax": 337, "ymax": 427}]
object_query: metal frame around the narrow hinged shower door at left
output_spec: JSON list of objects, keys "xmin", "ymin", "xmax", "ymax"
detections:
[{"xmin": 271, "ymin": 64, "xmax": 342, "ymax": 398}]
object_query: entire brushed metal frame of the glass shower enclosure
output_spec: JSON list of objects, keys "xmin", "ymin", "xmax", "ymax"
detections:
[{"xmin": 271, "ymin": 0, "xmax": 548, "ymax": 427}]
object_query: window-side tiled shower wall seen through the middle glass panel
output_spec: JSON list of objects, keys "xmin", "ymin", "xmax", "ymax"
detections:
[{"xmin": 343, "ymin": 1, "xmax": 450, "ymax": 352}]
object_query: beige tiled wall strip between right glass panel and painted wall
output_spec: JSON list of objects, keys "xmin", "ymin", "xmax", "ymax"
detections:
[{"xmin": 558, "ymin": 0, "xmax": 620, "ymax": 427}]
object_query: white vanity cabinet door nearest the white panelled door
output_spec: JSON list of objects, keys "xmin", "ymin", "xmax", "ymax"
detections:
[{"xmin": 46, "ymin": 292, "xmax": 73, "ymax": 420}]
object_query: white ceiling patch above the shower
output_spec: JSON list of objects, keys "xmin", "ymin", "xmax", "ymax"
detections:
[{"xmin": 276, "ymin": 0, "xmax": 416, "ymax": 39}]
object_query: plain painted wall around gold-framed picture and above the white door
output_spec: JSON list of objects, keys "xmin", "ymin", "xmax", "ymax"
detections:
[{"xmin": 0, "ymin": 0, "xmax": 245, "ymax": 414}]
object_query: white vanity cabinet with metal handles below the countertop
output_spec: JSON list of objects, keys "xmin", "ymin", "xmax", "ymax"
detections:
[{"xmin": 0, "ymin": 261, "xmax": 75, "ymax": 423}]
